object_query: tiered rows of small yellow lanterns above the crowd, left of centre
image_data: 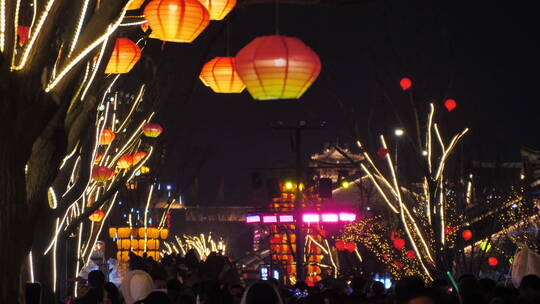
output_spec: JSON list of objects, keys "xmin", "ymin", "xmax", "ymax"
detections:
[{"xmin": 109, "ymin": 227, "xmax": 169, "ymax": 262}]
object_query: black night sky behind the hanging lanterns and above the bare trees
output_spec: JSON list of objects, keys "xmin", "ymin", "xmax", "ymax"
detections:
[{"xmin": 143, "ymin": 0, "xmax": 540, "ymax": 205}]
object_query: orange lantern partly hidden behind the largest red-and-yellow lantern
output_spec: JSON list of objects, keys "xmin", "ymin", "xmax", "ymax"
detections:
[{"xmin": 199, "ymin": 57, "xmax": 246, "ymax": 93}]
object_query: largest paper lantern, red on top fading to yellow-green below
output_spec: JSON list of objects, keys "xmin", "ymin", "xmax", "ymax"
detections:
[{"xmin": 234, "ymin": 35, "xmax": 321, "ymax": 100}]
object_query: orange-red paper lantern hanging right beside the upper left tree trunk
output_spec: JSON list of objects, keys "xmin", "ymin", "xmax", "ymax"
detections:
[{"xmin": 105, "ymin": 38, "xmax": 141, "ymax": 74}]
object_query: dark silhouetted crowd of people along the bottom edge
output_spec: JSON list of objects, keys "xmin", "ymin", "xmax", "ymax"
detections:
[{"xmin": 67, "ymin": 252, "xmax": 540, "ymax": 304}]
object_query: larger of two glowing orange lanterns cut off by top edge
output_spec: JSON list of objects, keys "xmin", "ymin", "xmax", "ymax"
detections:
[{"xmin": 144, "ymin": 0, "xmax": 210, "ymax": 42}]
